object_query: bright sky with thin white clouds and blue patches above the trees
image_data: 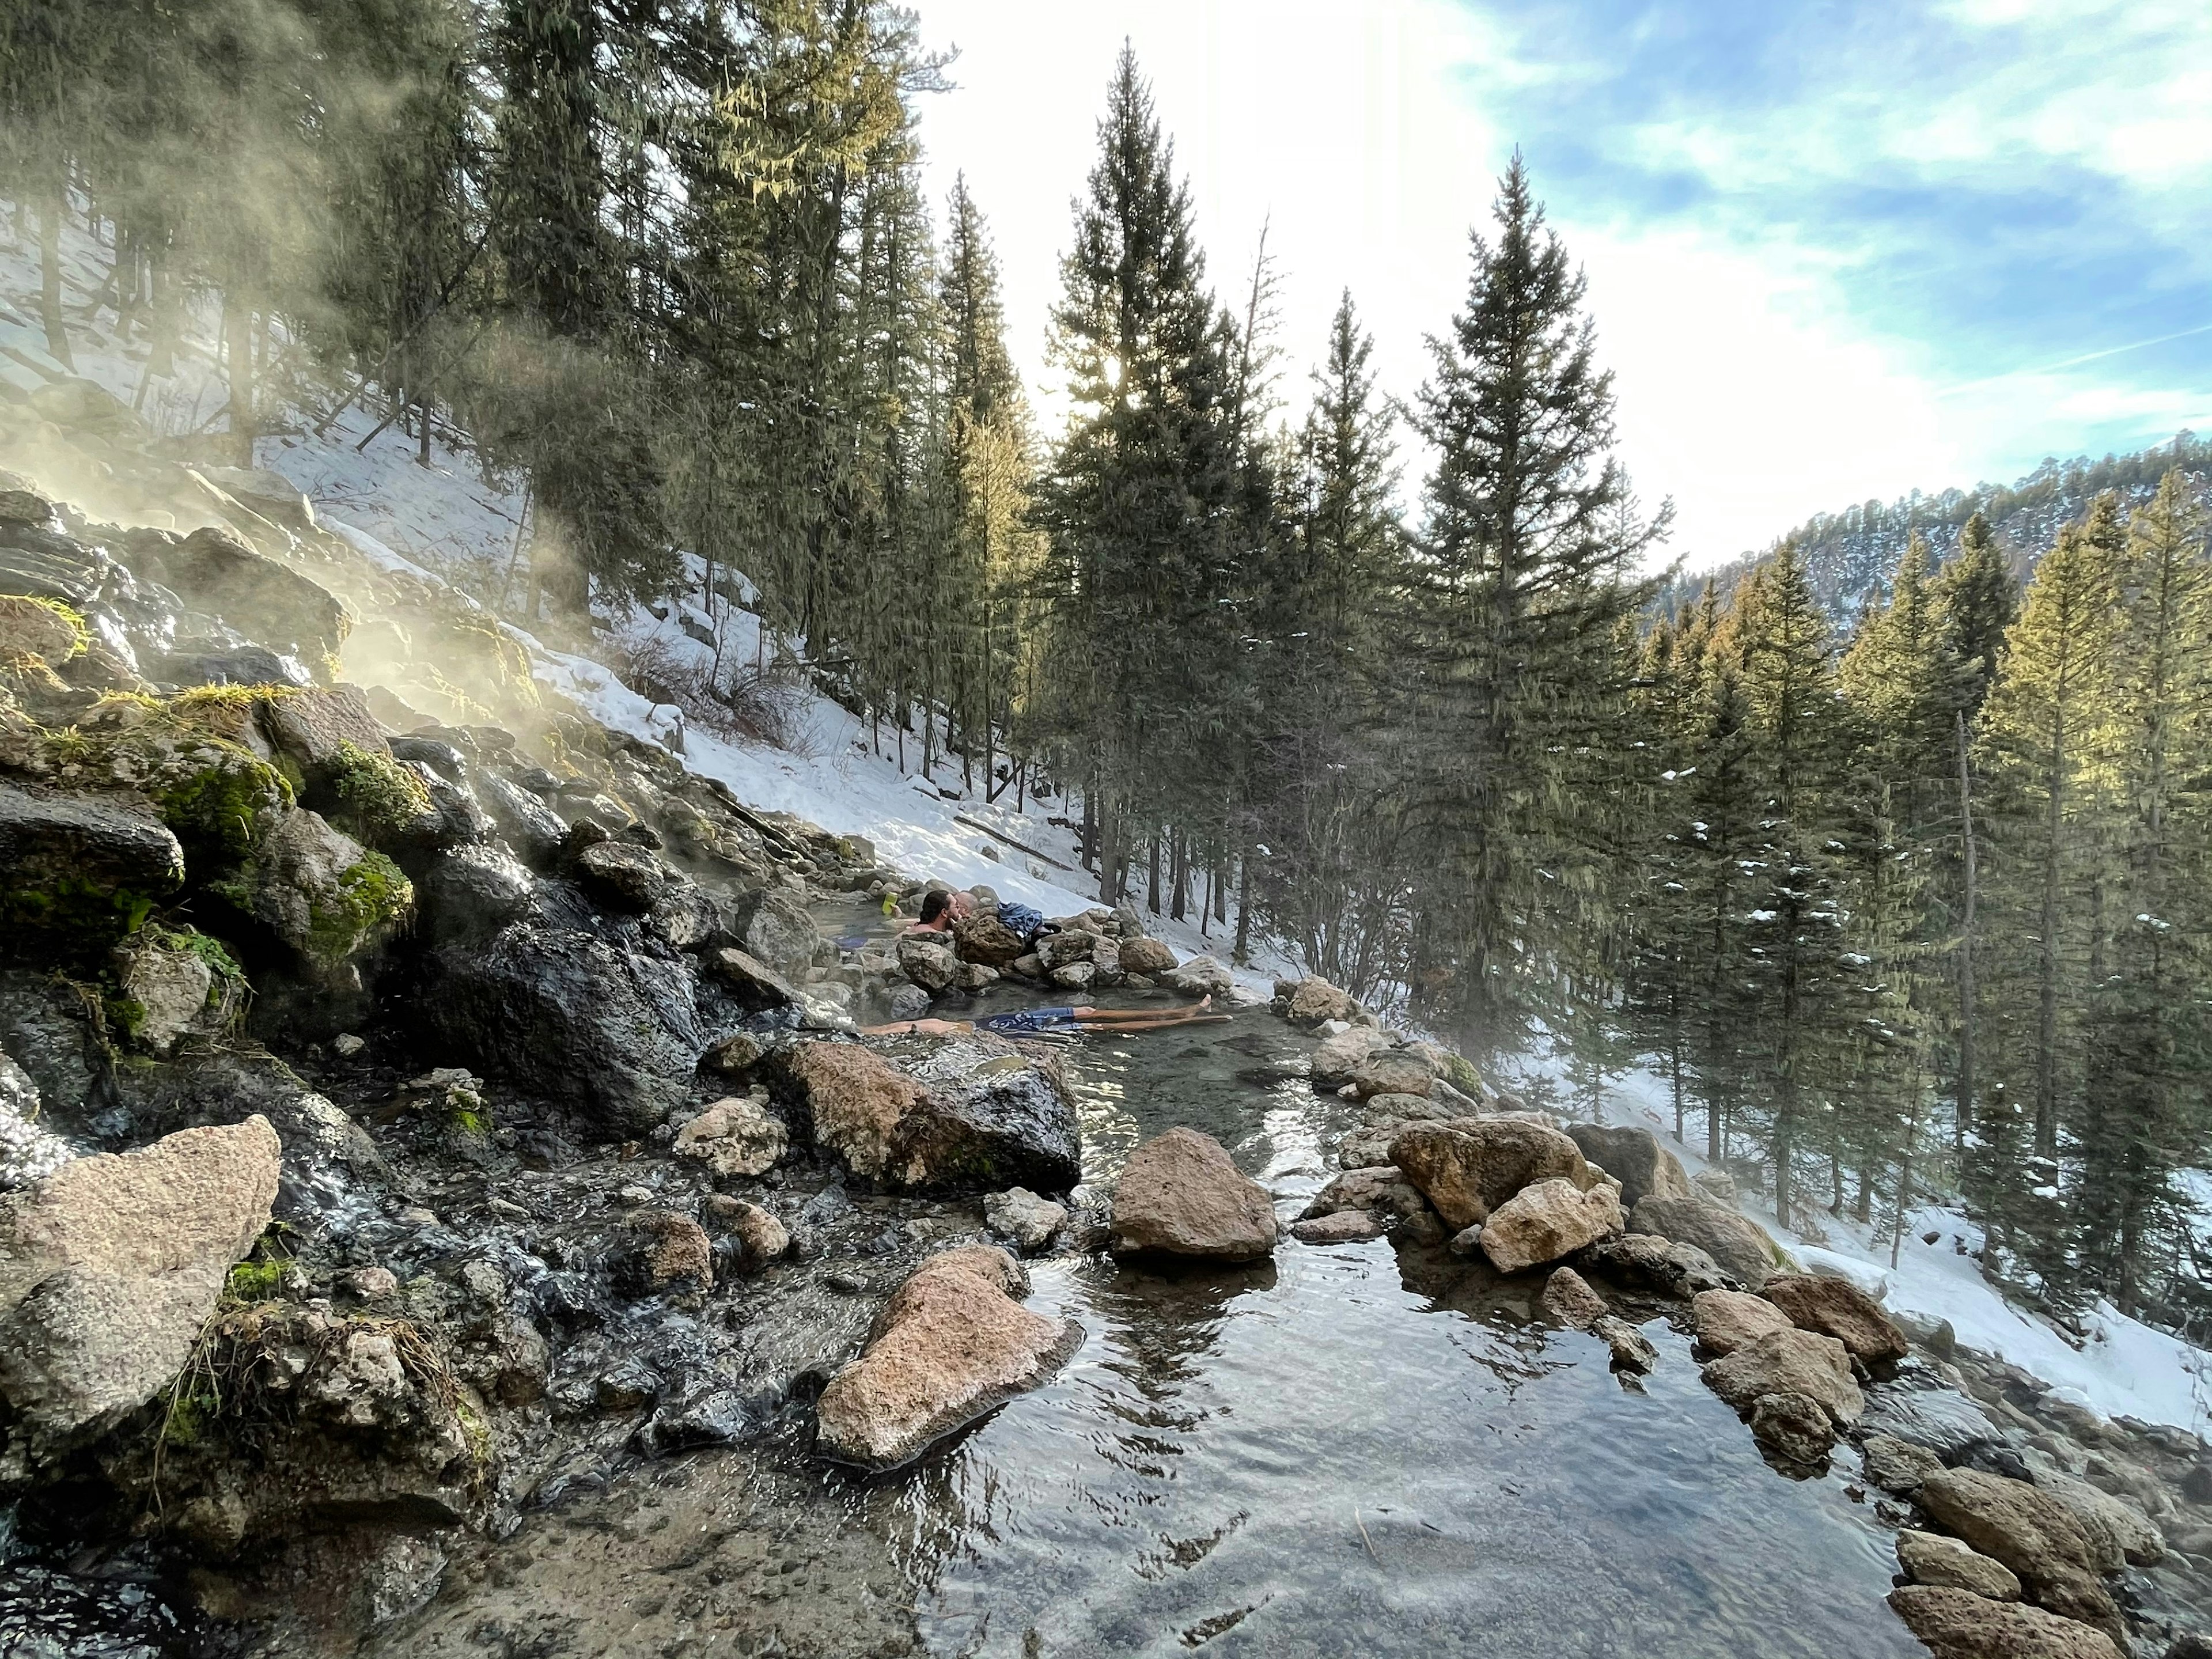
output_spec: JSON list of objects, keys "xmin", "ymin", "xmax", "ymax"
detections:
[{"xmin": 916, "ymin": 0, "xmax": 2212, "ymax": 564}]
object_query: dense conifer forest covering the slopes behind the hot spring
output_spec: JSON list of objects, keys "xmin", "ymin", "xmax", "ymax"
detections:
[{"xmin": 0, "ymin": 0, "xmax": 2212, "ymax": 1389}]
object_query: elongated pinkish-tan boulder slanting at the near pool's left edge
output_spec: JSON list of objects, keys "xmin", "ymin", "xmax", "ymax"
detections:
[{"xmin": 816, "ymin": 1245, "xmax": 1082, "ymax": 1469}]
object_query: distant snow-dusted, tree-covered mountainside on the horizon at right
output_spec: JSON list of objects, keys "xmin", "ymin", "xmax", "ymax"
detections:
[{"xmin": 1664, "ymin": 431, "xmax": 2212, "ymax": 628}]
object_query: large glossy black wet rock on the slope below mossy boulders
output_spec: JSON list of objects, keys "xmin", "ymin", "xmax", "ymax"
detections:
[{"xmin": 422, "ymin": 922, "xmax": 706, "ymax": 1135}]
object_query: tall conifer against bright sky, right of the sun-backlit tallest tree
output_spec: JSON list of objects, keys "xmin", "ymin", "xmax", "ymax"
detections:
[{"xmin": 1407, "ymin": 155, "xmax": 1657, "ymax": 1053}]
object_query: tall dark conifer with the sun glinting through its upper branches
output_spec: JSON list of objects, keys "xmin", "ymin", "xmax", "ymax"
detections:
[{"xmin": 1037, "ymin": 47, "xmax": 1248, "ymax": 900}]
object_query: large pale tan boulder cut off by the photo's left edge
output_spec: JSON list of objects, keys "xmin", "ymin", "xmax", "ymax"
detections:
[{"xmin": 0, "ymin": 1117, "xmax": 281, "ymax": 1484}]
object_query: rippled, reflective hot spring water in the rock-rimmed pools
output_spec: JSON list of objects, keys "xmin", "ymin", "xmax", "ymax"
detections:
[{"xmin": 801, "ymin": 968, "xmax": 1922, "ymax": 1659}]
